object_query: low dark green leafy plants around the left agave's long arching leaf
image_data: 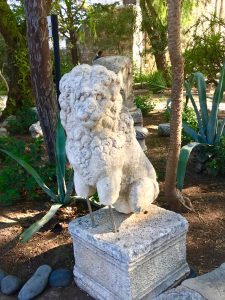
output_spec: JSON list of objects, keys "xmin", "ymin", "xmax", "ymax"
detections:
[{"xmin": 0, "ymin": 137, "xmax": 56, "ymax": 205}]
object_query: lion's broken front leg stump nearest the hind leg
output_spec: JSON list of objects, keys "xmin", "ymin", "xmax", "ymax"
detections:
[{"xmin": 97, "ymin": 170, "xmax": 122, "ymax": 205}]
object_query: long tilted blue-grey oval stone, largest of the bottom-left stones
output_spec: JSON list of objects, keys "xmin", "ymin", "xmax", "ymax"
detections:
[{"xmin": 18, "ymin": 265, "xmax": 52, "ymax": 300}]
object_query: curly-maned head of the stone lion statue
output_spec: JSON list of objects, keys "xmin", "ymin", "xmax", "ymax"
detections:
[{"xmin": 59, "ymin": 65, "xmax": 122, "ymax": 128}]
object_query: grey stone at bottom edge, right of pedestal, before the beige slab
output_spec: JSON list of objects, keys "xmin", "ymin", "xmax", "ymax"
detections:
[{"xmin": 155, "ymin": 286, "xmax": 204, "ymax": 300}]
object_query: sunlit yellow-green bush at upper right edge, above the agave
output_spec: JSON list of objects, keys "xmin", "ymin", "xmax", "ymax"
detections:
[{"xmin": 184, "ymin": 15, "xmax": 225, "ymax": 81}]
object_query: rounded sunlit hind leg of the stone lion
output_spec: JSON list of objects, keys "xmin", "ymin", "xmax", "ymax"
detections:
[{"xmin": 128, "ymin": 178, "xmax": 159, "ymax": 212}]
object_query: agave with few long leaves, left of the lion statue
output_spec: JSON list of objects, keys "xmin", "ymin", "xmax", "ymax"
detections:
[{"xmin": 0, "ymin": 118, "xmax": 74, "ymax": 242}]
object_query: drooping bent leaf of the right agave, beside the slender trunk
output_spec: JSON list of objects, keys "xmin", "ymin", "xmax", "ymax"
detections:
[{"xmin": 177, "ymin": 143, "xmax": 199, "ymax": 191}]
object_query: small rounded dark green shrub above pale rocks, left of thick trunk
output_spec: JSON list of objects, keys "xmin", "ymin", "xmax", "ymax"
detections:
[{"xmin": 7, "ymin": 108, "xmax": 38, "ymax": 134}]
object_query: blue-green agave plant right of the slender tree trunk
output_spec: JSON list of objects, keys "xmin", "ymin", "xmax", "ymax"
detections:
[{"xmin": 177, "ymin": 62, "xmax": 225, "ymax": 190}]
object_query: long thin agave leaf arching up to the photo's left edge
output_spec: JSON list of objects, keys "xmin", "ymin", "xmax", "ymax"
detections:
[{"xmin": 0, "ymin": 149, "xmax": 58, "ymax": 201}]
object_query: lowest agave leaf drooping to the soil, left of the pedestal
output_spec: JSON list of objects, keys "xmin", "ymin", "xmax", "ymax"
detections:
[{"xmin": 20, "ymin": 204, "xmax": 62, "ymax": 243}]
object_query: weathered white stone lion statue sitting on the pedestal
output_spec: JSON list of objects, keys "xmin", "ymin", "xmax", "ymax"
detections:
[{"xmin": 59, "ymin": 64, "xmax": 159, "ymax": 214}]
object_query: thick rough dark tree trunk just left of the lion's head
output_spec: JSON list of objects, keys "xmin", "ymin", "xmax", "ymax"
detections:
[{"xmin": 25, "ymin": 0, "xmax": 58, "ymax": 161}]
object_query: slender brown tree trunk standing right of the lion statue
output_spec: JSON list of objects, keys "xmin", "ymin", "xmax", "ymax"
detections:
[{"xmin": 165, "ymin": 0, "xmax": 192, "ymax": 211}]
